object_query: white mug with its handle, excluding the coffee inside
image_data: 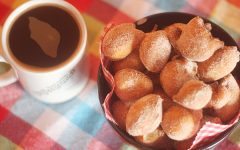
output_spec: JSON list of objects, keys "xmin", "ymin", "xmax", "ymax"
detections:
[{"xmin": 0, "ymin": 0, "xmax": 89, "ymax": 103}]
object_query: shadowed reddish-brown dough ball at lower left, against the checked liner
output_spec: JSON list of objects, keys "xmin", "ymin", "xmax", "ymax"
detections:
[{"xmin": 112, "ymin": 100, "xmax": 130, "ymax": 130}]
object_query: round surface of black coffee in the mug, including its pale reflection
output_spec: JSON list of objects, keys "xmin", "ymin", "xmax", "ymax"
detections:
[{"xmin": 9, "ymin": 6, "xmax": 80, "ymax": 67}]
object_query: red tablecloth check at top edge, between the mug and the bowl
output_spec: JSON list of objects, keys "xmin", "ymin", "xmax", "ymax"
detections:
[{"xmin": 87, "ymin": 0, "xmax": 134, "ymax": 24}]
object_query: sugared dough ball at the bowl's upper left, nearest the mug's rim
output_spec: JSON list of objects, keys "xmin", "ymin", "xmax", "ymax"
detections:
[{"xmin": 102, "ymin": 23, "xmax": 145, "ymax": 60}]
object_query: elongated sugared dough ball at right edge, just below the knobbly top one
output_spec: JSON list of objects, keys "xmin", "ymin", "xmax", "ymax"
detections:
[{"xmin": 198, "ymin": 46, "xmax": 239, "ymax": 82}]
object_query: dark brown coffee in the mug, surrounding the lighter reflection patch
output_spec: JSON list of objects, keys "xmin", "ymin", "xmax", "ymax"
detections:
[{"xmin": 9, "ymin": 6, "xmax": 80, "ymax": 68}]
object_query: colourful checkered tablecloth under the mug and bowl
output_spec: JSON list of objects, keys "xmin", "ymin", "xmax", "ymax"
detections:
[{"xmin": 0, "ymin": 0, "xmax": 240, "ymax": 150}]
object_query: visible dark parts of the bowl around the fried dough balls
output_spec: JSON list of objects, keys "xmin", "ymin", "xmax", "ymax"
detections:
[{"xmin": 98, "ymin": 12, "xmax": 240, "ymax": 150}]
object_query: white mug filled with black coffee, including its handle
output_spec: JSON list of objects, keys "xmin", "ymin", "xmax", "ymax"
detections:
[{"xmin": 0, "ymin": 0, "xmax": 88, "ymax": 103}]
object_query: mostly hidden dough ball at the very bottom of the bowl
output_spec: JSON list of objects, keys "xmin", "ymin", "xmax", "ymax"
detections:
[{"xmin": 135, "ymin": 128, "xmax": 173, "ymax": 149}]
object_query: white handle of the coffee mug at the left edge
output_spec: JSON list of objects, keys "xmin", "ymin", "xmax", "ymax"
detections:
[{"xmin": 0, "ymin": 55, "xmax": 18, "ymax": 87}]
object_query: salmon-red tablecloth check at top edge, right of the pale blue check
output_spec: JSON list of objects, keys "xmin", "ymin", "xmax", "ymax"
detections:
[{"xmin": 188, "ymin": 0, "xmax": 218, "ymax": 15}]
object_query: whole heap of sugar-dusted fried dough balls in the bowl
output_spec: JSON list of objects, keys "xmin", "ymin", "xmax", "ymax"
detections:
[{"xmin": 105, "ymin": 17, "xmax": 240, "ymax": 150}]
